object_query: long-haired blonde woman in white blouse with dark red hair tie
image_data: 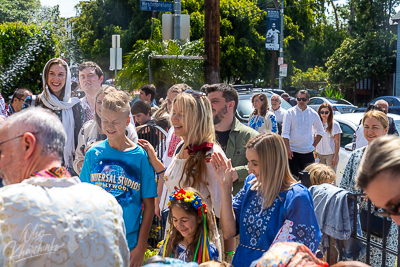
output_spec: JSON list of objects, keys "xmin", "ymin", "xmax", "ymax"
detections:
[{"xmin": 138, "ymin": 89, "xmax": 226, "ymax": 255}]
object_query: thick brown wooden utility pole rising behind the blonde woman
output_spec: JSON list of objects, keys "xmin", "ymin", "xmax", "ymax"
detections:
[{"xmin": 204, "ymin": 0, "xmax": 220, "ymax": 84}]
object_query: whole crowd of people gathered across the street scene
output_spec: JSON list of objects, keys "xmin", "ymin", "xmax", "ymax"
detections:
[{"xmin": 0, "ymin": 58, "xmax": 400, "ymax": 267}]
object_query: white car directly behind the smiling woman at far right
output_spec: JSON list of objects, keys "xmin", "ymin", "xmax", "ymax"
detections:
[{"xmin": 333, "ymin": 113, "xmax": 400, "ymax": 186}]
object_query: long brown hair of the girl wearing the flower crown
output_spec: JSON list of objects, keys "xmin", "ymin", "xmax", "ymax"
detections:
[{"xmin": 164, "ymin": 187, "xmax": 216, "ymax": 261}]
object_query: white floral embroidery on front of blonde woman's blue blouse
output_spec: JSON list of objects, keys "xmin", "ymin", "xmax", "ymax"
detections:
[{"xmin": 242, "ymin": 195, "xmax": 278, "ymax": 247}]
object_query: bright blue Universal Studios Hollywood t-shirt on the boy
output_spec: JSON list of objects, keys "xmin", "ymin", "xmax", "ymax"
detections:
[{"xmin": 79, "ymin": 140, "xmax": 157, "ymax": 250}]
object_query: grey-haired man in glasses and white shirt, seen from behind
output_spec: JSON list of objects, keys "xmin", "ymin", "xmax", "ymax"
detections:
[{"xmin": 0, "ymin": 107, "xmax": 129, "ymax": 266}]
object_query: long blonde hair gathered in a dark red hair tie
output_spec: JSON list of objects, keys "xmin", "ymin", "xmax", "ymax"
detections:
[{"xmin": 171, "ymin": 93, "xmax": 216, "ymax": 188}]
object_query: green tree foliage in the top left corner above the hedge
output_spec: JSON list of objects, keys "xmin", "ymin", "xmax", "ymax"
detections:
[{"xmin": 0, "ymin": 0, "xmax": 40, "ymax": 24}]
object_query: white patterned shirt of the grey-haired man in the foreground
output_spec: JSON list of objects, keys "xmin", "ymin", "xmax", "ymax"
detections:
[{"xmin": 0, "ymin": 177, "xmax": 129, "ymax": 267}]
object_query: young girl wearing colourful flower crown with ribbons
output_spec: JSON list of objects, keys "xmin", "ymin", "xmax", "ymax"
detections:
[{"xmin": 159, "ymin": 187, "xmax": 219, "ymax": 263}]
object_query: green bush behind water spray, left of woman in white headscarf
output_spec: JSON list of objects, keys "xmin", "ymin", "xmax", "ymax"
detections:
[{"xmin": 0, "ymin": 22, "xmax": 56, "ymax": 96}]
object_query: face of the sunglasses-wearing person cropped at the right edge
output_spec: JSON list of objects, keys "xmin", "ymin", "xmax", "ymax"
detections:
[{"xmin": 364, "ymin": 171, "xmax": 400, "ymax": 225}]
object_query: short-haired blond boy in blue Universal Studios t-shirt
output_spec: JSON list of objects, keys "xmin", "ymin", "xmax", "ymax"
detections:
[{"xmin": 79, "ymin": 91, "xmax": 157, "ymax": 266}]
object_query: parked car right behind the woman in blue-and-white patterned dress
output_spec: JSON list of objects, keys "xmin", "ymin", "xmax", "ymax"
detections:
[{"xmin": 236, "ymin": 89, "xmax": 292, "ymax": 125}]
